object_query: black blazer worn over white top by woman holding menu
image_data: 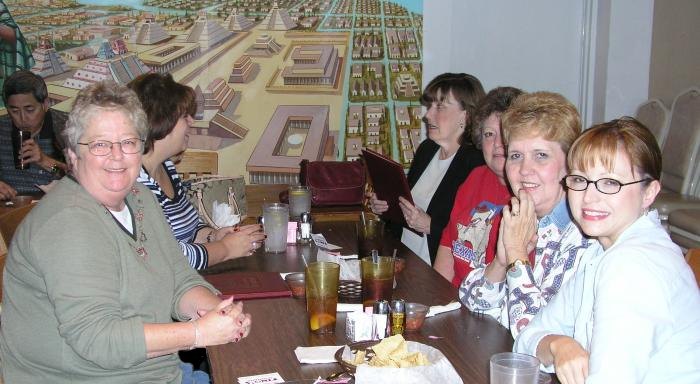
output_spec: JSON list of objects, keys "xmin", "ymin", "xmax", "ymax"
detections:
[{"xmin": 391, "ymin": 139, "xmax": 484, "ymax": 264}]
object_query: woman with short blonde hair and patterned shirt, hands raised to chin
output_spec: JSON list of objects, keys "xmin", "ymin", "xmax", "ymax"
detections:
[{"xmin": 459, "ymin": 92, "xmax": 589, "ymax": 337}]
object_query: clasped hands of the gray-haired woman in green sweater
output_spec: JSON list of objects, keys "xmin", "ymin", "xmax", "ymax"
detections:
[{"xmin": 195, "ymin": 298, "xmax": 252, "ymax": 347}]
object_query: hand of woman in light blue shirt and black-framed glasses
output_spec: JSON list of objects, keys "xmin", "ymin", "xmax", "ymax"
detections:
[{"xmin": 542, "ymin": 336, "xmax": 588, "ymax": 384}]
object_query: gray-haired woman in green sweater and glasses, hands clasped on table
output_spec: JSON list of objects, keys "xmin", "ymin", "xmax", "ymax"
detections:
[{"xmin": 0, "ymin": 83, "xmax": 251, "ymax": 384}]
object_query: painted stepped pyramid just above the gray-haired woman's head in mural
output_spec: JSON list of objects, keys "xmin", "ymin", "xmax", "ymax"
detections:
[{"xmin": 63, "ymin": 39, "xmax": 151, "ymax": 89}]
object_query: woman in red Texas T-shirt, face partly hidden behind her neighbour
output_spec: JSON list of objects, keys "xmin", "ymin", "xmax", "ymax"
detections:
[{"xmin": 434, "ymin": 87, "xmax": 522, "ymax": 287}]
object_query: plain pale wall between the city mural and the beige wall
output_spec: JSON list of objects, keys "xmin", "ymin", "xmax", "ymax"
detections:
[{"xmin": 424, "ymin": 0, "xmax": 653, "ymax": 126}]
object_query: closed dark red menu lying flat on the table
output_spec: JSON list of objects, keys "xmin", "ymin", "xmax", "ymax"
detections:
[{"xmin": 203, "ymin": 271, "xmax": 292, "ymax": 300}]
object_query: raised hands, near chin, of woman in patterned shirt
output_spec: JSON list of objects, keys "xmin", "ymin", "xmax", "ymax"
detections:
[{"xmin": 496, "ymin": 190, "xmax": 537, "ymax": 265}]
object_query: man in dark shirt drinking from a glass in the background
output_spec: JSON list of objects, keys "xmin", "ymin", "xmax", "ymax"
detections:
[{"xmin": 0, "ymin": 70, "xmax": 67, "ymax": 199}]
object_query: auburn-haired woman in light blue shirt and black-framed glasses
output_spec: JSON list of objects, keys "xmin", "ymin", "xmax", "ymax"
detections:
[{"xmin": 515, "ymin": 118, "xmax": 700, "ymax": 384}]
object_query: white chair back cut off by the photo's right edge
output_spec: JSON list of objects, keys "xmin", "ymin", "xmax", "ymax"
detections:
[{"xmin": 661, "ymin": 87, "xmax": 700, "ymax": 195}]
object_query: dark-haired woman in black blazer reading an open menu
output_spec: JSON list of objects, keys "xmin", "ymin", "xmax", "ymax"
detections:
[{"xmin": 369, "ymin": 73, "xmax": 484, "ymax": 265}]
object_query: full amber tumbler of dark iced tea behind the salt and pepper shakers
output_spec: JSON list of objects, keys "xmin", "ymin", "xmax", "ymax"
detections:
[{"xmin": 360, "ymin": 256, "xmax": 394, "ymax": 307}]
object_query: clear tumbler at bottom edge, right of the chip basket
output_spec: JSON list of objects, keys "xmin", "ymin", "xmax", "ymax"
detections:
[{"xmin": 490, "ymin": 352, "xmax": 540, "ymax": 384}]
